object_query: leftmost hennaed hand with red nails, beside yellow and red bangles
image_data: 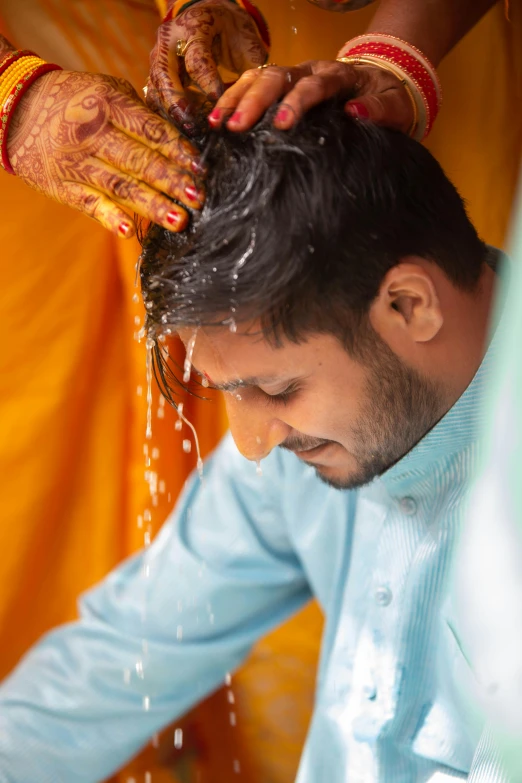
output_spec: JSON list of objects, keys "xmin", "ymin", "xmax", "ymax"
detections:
[{"xmin": 7, "ymin": 71, "xmax": 204, "ymax": 238}]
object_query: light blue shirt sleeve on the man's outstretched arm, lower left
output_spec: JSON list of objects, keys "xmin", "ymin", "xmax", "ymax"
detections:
[{"xmin": 0, "ymin": 437, "xmax": 310, "ymax": 783}]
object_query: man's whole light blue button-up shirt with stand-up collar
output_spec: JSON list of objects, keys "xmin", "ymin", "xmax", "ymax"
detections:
[{"xmin": 0, "ymin": 322, "xmax": 504, "ymax": 783}]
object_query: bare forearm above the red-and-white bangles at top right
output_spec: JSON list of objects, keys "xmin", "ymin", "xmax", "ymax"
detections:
[{"xmin": 367, "ymin": 0, "xmax": 496, "ymax": 65}]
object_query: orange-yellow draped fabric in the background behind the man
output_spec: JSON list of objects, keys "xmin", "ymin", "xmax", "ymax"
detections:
[{"xmin": 0, "ymin": 0, "xmax": 522, "ymax": 783}]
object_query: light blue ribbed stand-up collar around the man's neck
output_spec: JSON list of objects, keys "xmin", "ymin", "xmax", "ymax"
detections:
[{"xmin": 380, "ymin": 251, "xmax": 506, "ymax": 490}]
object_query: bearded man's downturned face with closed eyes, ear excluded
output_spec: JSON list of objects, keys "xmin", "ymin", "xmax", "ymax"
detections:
[{"xmin": 180, "ymin": 326, "xmax": 444, "ymax": 489}]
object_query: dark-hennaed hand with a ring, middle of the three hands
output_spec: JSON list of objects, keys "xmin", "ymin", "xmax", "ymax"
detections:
[{"xmin": 146, "ymin": 0, "xmax": 268, "ymax": 127}]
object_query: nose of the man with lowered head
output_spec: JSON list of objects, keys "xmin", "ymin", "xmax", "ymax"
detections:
[{"xmin": 225, "ymin": 394, "xmax": 292, "ymax": 460}]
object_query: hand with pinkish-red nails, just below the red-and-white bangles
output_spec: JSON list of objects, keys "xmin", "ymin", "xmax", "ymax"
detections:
[{"xmin": 209, "ymin": 60, "xmax": 413, "ymax": 133}]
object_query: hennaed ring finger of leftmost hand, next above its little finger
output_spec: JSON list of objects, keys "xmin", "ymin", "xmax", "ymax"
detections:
[{"xmin": 69, "ymin": 158, "xmax": 188, "ymax": 231}]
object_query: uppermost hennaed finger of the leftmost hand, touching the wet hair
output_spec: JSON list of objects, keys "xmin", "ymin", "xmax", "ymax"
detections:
[{"xmin": 106, "ymin": 96, "xmax": 201, "ymax": 174}]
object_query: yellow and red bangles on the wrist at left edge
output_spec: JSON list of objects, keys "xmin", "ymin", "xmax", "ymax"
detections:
[{"xmin": 0, "ymin": 49, "xmax": 62, "ymax": 174}]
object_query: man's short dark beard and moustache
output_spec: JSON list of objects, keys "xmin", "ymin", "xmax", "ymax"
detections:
[{"xmin": 282, "ymin": 334, "xmax": 449, "ymax": 489}]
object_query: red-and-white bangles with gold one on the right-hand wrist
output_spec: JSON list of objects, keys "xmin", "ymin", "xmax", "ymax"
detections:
[{"xmin": 337, "ymin": 33, "xmax": 442, "ymax": 141}]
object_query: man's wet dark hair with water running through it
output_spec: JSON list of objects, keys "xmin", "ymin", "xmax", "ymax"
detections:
[{"xmin": 141, "ymin": 100, "xmax": 486, "ymax": 398}]
